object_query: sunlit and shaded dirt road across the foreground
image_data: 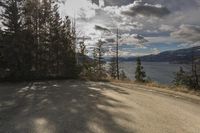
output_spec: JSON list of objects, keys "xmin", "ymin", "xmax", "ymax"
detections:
[{"xmin": 0, "ymin": 81, "xmax": 200, "ymax": 133}]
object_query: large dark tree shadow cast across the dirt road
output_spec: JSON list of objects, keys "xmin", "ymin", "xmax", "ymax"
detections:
[{"xmin": 0, "ymin": 81, "xmax": 134, "ymax": 133}]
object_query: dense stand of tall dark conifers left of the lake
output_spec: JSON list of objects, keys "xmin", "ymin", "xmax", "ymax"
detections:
[{"xmin": 0, "ymin": 0, "xmax": 80, "ymax": 79}]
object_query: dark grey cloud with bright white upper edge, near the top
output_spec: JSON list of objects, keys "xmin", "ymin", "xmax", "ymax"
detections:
[{"xmin": 121, "ymin": 0, "xmax": 170, "ymax": 17}]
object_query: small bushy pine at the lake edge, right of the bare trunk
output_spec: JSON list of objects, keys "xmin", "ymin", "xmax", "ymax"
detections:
[{"xmin": 135, "ymin": 58, "xmax": 146, "ymax": 82}]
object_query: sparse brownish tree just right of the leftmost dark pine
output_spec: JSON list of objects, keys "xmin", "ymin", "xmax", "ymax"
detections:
[{"xmin": 23, "ymin": 0, "xmax": 42, "ymax": 78}]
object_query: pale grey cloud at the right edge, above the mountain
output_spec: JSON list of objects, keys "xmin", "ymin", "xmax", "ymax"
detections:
[{"xmin": 171, "ymin": 25, "xmax": 200, "ymax": 43}]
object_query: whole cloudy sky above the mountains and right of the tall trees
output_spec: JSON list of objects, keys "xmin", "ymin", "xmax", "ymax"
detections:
[{"xmin": 60, "ymin": 0, "xmax": 200, "ymax": 57}]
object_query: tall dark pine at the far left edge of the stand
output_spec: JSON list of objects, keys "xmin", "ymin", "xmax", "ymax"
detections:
[{"xmin": 1, "ymin": 0, "xmax": 24, "ymax": 78}]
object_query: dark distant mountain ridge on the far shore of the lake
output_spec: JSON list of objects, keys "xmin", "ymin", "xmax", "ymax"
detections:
[{"xmin": 120, "ymin": 46, "xmax": 200, "ymax": 63}]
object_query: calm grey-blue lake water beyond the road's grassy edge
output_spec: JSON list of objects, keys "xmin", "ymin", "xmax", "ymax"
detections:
[{"xmin": 120, "ymin": 62, "xmax": 191, "ymax": 85}]
